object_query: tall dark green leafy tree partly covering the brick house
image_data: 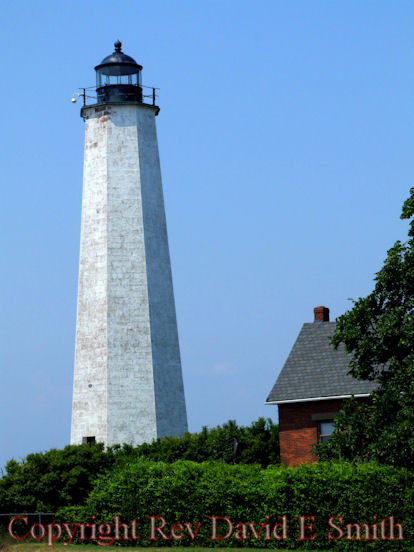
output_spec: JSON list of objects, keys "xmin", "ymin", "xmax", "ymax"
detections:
[{"xmin": 315, "ymin": 188, "xmax": 414, "ymax": 468}]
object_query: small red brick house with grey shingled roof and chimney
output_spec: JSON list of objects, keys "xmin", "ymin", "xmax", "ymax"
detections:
[{"xmin": 266, "ymin": 307, "xmax": 375, "ymax": 466}]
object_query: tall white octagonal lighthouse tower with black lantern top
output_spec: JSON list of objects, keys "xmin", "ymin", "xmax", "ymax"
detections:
[{"xmin": 71, "ymin": 41, "xmax": 187, "ymax": 445}]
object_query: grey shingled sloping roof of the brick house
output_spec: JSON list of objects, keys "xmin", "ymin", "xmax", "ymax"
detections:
[{"xmin": 266, "ymin": 307, "xmax": 376, "ymax": 404}]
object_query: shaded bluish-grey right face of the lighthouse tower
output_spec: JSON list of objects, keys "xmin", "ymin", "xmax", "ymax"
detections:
[{"xmin": 137, "ymin": 105, "xmax": 188, "ymax": 437}]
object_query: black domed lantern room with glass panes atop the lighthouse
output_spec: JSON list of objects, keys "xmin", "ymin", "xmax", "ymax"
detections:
[{"xmin": 95, "ymin": 40, "xmax": 142, "ymax": 103}]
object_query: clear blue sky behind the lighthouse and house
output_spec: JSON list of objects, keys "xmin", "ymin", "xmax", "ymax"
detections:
[{"xmin": 0, "ymin": 0, "xmax": 414, "ymax": 466}]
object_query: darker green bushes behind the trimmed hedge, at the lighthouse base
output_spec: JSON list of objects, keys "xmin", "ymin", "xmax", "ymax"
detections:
[{"xmin": 0, "ymin": 418, "xmax": 279, "ymax": 513}]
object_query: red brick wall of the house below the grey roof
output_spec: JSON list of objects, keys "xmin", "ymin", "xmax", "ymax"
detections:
[{"xmin": 279, "ymin": 399, "xmax": 343, "ymax": 466}]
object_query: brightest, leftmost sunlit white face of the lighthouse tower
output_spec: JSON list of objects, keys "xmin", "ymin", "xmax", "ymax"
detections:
[{"xmin": 71, "ymin": 112, "xmax": 108, "ymax": 443}]
